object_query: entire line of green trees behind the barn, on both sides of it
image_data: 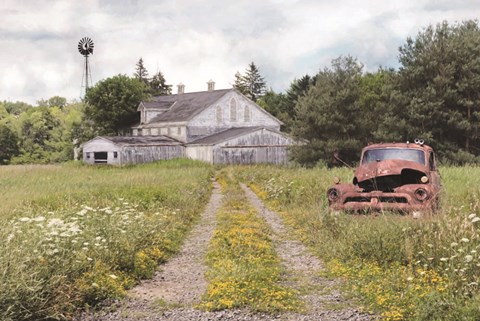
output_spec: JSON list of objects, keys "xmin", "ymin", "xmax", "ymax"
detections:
[{"xmin": 0, "ymin": 20, "xmax": 480, "ymax": 165}]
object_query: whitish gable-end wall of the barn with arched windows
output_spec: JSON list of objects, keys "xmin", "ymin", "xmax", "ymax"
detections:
[{"xmin": 187, "ymin": 92, "xmax": 280, "ymax": 141}]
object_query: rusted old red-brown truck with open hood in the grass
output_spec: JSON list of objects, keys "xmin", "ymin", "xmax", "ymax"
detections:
[{"xmin": 327, "ymin": 141, "xmax": 441, "ymax": 212}]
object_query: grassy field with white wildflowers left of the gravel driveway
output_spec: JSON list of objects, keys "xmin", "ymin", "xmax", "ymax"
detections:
[{"xmin": 0, "ymin": 160, "xmax": 213, "ymax": 320}]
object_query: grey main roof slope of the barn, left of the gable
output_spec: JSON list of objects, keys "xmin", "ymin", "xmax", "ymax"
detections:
[{"xmin": 139, "ymin": 89, "xmax": 234, "ymax": 123}]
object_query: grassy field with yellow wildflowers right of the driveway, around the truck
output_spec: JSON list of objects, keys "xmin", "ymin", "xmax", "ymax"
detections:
[{"xmin": 237, "ymin": 166, "xmax": 480, "ymax": 320}]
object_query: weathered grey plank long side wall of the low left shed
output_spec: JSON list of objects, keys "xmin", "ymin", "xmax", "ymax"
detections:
[{"xmin": 121, "ymin": 145, "xmax": 185, "ymax": 164}]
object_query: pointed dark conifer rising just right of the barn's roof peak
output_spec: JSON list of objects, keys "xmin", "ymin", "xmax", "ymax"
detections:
[{"xmin": 233, "ymin": 61, "xmax": 266, "ymax": 101}]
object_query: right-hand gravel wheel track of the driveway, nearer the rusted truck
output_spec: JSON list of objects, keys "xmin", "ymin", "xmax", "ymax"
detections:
[{"xmin": 241, "ymin": 184, "xmax": 375, "ymax": 321}]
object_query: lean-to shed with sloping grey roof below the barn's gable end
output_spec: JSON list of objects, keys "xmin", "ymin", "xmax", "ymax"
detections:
[{"xmin": 185, "ymin": 127, "xmax": 293, "ymax": 164}]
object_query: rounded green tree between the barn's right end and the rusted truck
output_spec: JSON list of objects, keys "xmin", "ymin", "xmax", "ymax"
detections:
[{"xmin": 292, "ymin": 56, "xmax": 370, "ymax": 165}]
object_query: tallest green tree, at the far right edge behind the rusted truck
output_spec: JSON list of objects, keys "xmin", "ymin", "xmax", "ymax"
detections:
[{"xmin": 396, "ymin": 21, "xmax": 480, "ymax": 162}]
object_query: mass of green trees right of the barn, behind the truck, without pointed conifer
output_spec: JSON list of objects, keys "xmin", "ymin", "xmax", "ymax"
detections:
[{"xmin": 259, "ymin": 21, "xmax": 480, "ymax": 165}]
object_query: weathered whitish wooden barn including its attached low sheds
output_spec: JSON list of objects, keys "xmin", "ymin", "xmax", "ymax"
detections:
[{"xmin": 83, "ymin": 82, "xmax": 293, "ymax": 165}]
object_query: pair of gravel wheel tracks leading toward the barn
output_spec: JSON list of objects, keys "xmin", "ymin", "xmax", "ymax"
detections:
[{"xmin": 75, "ymin": 183, "xmax": 373, "ymax": 321}]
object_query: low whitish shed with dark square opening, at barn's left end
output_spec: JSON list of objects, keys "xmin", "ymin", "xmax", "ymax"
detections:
[{"xmin": 82, "ymin": 136, "xmax": 185, "ymax": 165}]
